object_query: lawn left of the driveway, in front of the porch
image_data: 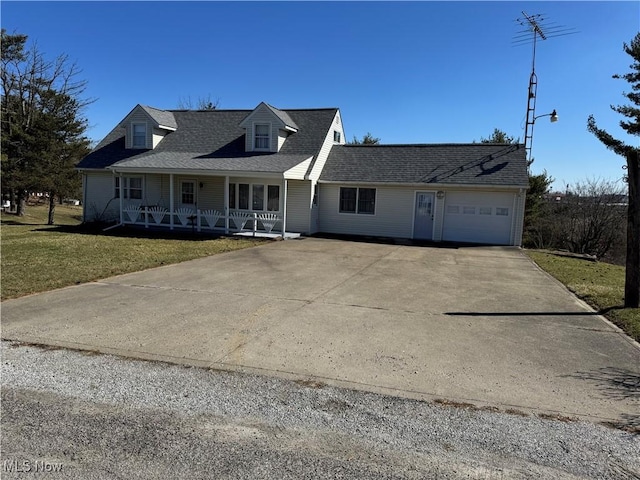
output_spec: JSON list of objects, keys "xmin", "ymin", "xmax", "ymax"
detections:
[{"xmin": 0, "ymin": 206, "xmax": 265, "ymax": 300}]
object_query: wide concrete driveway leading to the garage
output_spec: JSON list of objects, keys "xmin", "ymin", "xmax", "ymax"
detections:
[{"xmin": 2, "ymin": 238, "xmax": 640, "ymax": 426}]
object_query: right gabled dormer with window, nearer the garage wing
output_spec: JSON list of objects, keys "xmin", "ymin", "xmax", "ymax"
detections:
[{"xmin": 240, "ymin": 102, "xmax": 298, "ymax": 153}]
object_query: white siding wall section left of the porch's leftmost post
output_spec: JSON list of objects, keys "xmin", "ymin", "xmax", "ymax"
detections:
[{"xmin": 84, "ymin": 171, "xmax": 120, "ymax": 222}]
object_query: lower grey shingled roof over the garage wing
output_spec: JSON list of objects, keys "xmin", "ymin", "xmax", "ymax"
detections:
[{"xmin": 320, "ymin": 143, "xmax": 529, "ymax": 187}]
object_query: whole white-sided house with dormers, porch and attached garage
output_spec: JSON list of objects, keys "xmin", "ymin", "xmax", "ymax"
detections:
[{"xmin": 78, "ymin": 103, "xmax": 528, "ymax": 245}]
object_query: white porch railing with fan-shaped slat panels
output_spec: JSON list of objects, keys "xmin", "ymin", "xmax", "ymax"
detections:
[{"xmin": 122, "ymin": 205, "xmax": 282, "ymax": 235}]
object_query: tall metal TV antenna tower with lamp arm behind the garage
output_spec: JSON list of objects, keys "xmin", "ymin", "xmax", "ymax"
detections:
[{"xmin": 511, "ymin": 11, "xmax": 578, "ymax": 164}]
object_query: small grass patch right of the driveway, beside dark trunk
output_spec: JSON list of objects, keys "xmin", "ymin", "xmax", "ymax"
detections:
[{"xmin": 526, "ymin": 250, "xmax": 640, "ymax": 341}]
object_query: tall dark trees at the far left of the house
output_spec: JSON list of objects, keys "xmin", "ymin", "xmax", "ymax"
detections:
[{"xmin": 0, "ymin": 29, "xmax": 91, "ymax": 225}]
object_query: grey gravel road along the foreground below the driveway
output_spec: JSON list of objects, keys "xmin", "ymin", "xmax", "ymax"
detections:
[{"xmin": 0, "ymin": 342, "xmax": 640, "ymax": 479}]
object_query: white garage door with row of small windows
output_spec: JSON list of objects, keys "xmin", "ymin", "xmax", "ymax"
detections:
[{"xmin": 442, "ymin": 192, "xmax": 514, "ymax": 245}]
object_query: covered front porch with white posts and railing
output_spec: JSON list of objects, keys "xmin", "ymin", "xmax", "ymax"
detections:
[{"xmin": 114, "ymin": 171, "xmax": 300, "ymax": 238}]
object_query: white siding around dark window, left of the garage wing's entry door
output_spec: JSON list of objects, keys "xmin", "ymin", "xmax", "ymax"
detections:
[{"xmin": 319, "ymin": 184, "xmax": 416, "ymax": 238}]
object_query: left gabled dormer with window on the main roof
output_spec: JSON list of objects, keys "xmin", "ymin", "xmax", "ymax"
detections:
[{"xmin": 120, "ymin": 105, "xmax": 178, "ymax": 150}]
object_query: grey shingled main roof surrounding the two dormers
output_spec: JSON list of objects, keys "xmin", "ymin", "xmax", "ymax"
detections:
[{"xmin": 77, "ymin": 107, "xmax": 337, "ymax": 172}]
